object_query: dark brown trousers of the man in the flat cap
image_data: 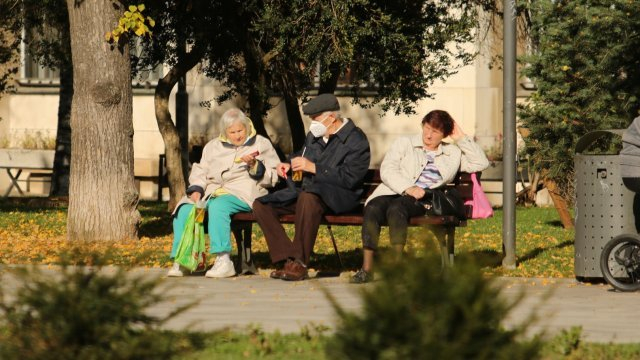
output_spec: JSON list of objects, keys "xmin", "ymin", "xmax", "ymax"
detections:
[{"xmin": 253, "ymin": 191, "xmax": 327, "ymax": 264}]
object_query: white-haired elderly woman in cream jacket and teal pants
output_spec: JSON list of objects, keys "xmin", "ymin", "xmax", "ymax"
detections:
[{"xmin": 167, "ymin": 108, "xmax": 280, "ymax": 278}]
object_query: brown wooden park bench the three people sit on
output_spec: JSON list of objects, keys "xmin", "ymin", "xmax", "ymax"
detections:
[{"xmin": 231, "ymin": 169, "xmax": 480, "ymax": 274}]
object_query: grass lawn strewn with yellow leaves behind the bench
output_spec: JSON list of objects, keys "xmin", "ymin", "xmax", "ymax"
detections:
[{"xmin": 0, "ymin": 199, "xmax": 574, "ymax": 277}]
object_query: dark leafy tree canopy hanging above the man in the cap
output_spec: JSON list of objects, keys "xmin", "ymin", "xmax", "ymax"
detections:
[{"xmin": 255, "ymin": 0, "xmax": 478, "ymax": 113}]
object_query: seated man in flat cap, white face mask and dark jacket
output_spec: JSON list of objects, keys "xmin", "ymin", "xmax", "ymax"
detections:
[{"xmin": 253, "ymin": 94, "xmax": 370, "ymax": 281}]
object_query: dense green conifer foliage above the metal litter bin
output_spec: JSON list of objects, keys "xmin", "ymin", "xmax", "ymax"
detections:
[{"xmin": 519, "ymin": 0, "xmax": 640, "ymax": 187}]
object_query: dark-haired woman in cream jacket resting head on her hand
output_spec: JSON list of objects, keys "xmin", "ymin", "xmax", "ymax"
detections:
[{"xmin": 351, "ymin": 110, "xmax": 489, "ymax": 283}]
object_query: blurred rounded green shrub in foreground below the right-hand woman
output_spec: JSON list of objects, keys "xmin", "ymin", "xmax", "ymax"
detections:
[{"xmin": 326, "ymin": 254, "xmax": 541, "ymax": 360}]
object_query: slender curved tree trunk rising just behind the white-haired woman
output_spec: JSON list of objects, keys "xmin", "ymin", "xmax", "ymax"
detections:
[{"xmin": 154, "ymin": 44, "xmax": 204, "ymax": 210}]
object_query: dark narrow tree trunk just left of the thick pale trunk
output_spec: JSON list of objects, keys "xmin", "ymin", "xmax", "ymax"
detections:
[{"xmin": 49, "ymin": 58, "xmax": 73, "ymax": 197}]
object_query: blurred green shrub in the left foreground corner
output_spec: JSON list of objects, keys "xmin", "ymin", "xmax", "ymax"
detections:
[{"xmin": 0, "ymin": 258, "xmax": 203, "ymax": 360}]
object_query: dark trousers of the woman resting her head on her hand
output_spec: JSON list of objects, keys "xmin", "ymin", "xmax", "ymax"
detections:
[{"xmin": 362, "ymin": 195, "xmax": 426, "ymax": 250}]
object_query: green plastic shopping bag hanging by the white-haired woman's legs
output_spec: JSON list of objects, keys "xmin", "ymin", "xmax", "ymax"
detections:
[{"xmin": 175, "ymin": 206, "xmax": 206, "ymax": 271}]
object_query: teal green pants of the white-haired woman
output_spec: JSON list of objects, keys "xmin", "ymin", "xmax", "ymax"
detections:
[{"xmin": 171, "ymin": 194, "xmax": 251, "ymax": 259}]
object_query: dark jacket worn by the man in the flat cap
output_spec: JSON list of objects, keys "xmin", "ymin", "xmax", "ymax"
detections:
[{"xmin": 296, "ymin": 120, "xmax": 371, "ymax": 213}]
